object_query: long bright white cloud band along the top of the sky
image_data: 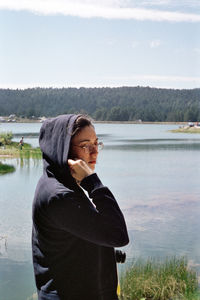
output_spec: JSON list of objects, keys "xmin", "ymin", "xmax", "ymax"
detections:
[{"xmin": 0, "ymin": 0, "xmax": 200, "ymax": 22}]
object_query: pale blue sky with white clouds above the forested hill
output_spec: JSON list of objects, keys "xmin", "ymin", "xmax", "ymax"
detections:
[{"xmin": 0, "ymin": 0, "xmax": 200, "ymax": 89}]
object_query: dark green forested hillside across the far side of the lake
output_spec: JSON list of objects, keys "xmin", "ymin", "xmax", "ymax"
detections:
[{"xmin": 0, "ymin": 86, "xmax": 200, "ymax": 122}]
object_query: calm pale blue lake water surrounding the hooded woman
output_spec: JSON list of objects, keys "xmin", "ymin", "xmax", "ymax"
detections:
[{"xmin": 0, "ymin": 123, "xmax": 200, "ymax": 300}]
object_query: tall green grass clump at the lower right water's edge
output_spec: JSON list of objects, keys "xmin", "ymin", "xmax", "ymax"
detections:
[{"xmin": 120, "ymin": 257, "xmax": 200, "ymax": 300}]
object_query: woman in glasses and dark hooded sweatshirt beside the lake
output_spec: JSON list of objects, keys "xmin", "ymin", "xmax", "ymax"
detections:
[{"xmin": 32, "ymin": 115, "xmax": 129, "ymax": 300}]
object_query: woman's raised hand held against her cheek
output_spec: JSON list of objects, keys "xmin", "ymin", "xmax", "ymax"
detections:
[{"xmin": 68, "ymin": 159, "xmax": 93, "ymax": 182}]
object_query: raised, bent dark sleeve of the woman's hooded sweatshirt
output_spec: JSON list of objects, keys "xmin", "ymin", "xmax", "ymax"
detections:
[{"xmin": 45, "ymin": 174, "xmax": 129, "ymax": 247}]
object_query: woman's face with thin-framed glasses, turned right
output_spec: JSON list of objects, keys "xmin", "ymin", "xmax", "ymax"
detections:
[{"xmin": 70, "ymin": 126, "xmax": 98, "ymax": 170}]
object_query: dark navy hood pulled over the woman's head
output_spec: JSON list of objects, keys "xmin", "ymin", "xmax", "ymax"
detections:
[{"xmin": 39, "ymin": 114, "xmax": 79, "ymax": 185}]
